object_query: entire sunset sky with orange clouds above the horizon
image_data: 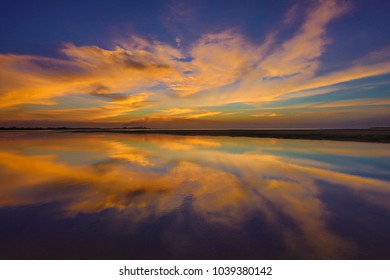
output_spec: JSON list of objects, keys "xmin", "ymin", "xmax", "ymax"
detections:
[{"xmin": 0, "ymin": 0, "xmax": 390, "ymax": 128}]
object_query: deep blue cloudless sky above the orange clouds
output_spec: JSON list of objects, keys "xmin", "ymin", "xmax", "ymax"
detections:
[{"xmin": 0, "ymin": 0, "xmax": 390, "ymax": 55}]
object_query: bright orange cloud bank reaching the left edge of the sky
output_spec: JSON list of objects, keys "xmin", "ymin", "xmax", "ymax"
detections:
[{"xmin": 0, "ymin": 38, "xmax": 180, "ymax": 107}]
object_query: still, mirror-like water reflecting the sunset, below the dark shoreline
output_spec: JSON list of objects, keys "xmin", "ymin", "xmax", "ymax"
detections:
[{"xmin": 0, "ymin": 131, "xmax": 390, "ymax": 259}]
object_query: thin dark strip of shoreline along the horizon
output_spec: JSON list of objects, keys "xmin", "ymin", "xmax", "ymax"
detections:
[{"xmin": 0, "ymin": 128, "xmax": 390, "ymax": 143}]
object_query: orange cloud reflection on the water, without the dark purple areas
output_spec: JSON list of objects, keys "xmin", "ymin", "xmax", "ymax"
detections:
[{"xmin": 0, "ymin": 133, "xmax": 390, "ymax": 258}]
